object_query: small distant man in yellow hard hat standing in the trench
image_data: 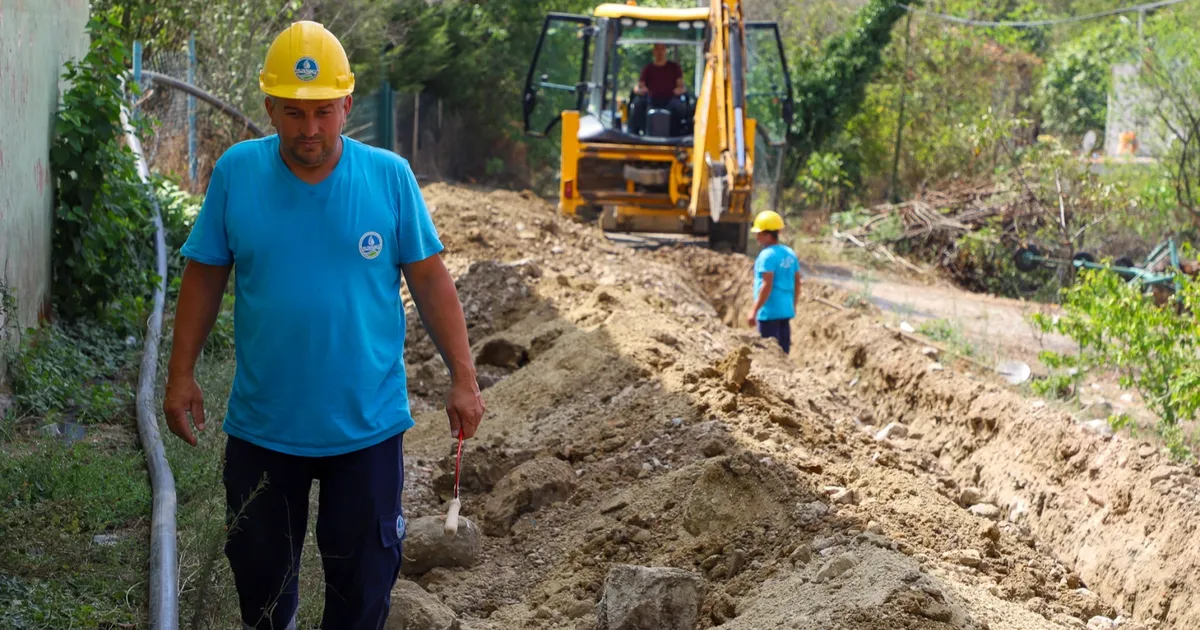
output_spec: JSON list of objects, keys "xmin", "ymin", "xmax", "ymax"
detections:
[{"xmin": 746, "ymin": 210, "xmax": 800, "ymax": 354}]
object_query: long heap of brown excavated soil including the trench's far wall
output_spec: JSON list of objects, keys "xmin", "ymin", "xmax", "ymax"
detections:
[{"xmin": 388, "ymin": 184, "xmax": 1200, "ymax": 630}]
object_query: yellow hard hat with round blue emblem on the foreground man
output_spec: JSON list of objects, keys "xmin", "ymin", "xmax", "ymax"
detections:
[{"xmin": 258, "ymin": 22, "xmax": 354, "ymax": 101}]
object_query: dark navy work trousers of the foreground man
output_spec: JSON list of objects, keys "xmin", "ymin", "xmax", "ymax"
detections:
[{"xmin": 223, "ymin": 434, "xmax": 404, "ymax": 630}]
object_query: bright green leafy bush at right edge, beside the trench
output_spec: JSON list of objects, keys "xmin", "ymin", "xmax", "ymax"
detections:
[{"xmin": 1031, "ymin": 262, "xmax": 1200, "ymax": 457}]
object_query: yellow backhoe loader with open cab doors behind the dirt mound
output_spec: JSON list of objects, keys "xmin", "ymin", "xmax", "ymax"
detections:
[{"xmin": 523, "ymin": 0, "xmax": 793, "ymax": 252}]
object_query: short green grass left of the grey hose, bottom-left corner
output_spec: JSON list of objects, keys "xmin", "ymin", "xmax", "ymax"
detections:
[{"xmin": 0, "ymin": 439, "xmax": 150, "ymax": 630}]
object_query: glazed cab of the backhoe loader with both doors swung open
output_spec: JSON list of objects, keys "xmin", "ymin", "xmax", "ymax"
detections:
[{"xmin": 523, "ymin": 4, "xmax": 792, "ymax": 148}]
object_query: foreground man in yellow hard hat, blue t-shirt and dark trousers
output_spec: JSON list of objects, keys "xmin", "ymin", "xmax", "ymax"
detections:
[{"xmin": 163, "ymin": 22, "xmax": 485, "ymax": 630}]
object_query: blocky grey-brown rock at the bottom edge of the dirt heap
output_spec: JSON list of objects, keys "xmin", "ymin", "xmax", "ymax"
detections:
[{"xmin": 598, "ymin": 564, "xmax": 704, "ymax": 630}]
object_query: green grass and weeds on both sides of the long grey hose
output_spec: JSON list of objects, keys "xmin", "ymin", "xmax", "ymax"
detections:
[{"xmin": 0, "ymin": 292, "xmax": 333, "ymax": 630}]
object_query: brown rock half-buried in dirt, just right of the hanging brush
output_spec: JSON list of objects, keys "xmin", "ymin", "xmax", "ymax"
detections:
[{"xmin": 484, "ymin": 457, "xmax": 575, "ymax": 536}]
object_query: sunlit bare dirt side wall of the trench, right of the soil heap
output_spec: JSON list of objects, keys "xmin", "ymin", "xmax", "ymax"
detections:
[{"xmin": 666, "ymin": 246, "xmax": 1200, "ymax": 629}]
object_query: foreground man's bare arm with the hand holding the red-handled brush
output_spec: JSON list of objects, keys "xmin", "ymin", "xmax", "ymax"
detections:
[{"xmin": 401, "ymin": 254, "xmax": 485, "ymax": 438}]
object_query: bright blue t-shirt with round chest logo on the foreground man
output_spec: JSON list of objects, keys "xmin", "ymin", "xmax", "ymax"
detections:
[{"xmin": 182, "ymin": 136, "xmax": 442, "ymax": 456}]
